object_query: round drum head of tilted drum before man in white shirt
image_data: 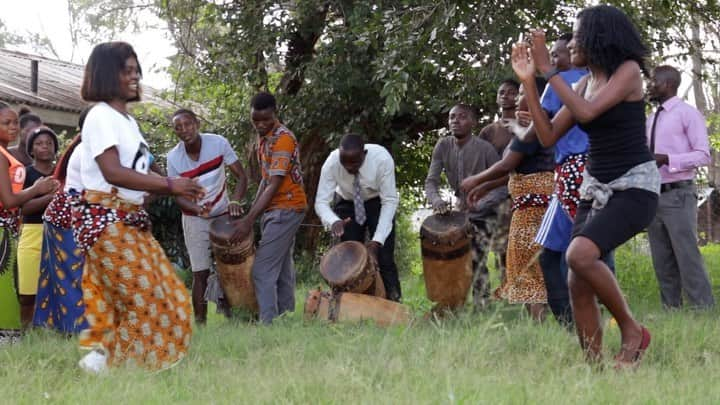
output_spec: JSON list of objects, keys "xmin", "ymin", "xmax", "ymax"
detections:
[{"xmin": 320, "ymin": 241, "xmax": 368, "ymax": 286}]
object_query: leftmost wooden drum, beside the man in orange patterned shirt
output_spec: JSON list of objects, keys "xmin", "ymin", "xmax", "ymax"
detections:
[{"xmin": 210, "ymin": 214, "xmax": 259, "ymax": 313}]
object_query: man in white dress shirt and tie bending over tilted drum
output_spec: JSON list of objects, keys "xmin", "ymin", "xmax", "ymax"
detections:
[{"xmin": 315, "ymin": 134, "xmax": 401, "ymax": 301}]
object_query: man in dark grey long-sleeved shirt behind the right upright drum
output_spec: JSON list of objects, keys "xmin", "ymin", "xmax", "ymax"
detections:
[{"xmin": 425, "ymin": 104, "xmax": 507, "ymax": 308}]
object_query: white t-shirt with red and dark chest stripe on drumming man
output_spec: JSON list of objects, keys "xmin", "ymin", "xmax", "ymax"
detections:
[{"xmin": 167, "ymin": 134, "xmax": 238, "ymax": 217}]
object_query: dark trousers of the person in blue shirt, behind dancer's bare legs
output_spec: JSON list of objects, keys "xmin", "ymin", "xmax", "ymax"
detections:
[{"xmin": 540, "ymin": 248, "xmax": 615, "ymax": 328}]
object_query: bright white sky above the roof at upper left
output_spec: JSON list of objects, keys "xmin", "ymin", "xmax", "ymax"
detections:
[{"xmin": 0, "ymin": 0, "xmax": 174, "ymax": 89}]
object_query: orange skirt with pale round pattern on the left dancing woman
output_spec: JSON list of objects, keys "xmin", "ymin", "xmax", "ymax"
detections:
[{"xmin": 80, "ymin": 193, "xmax": 192, "ymax": 370}]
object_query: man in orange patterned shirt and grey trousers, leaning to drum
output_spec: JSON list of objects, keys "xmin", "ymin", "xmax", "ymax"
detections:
[{"xmin": 231, "ymin": 93, "xmax": 307, "ymax": 324}]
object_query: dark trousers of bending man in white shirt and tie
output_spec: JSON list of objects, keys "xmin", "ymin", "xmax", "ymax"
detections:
[{"xmin": 335, "ymin": 197, "xmax": 402, "ymax": 301}]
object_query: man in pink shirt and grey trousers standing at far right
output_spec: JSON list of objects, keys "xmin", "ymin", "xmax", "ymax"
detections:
[{"xmin": 647, "ymin": 66, "xmax": 715, "ymax": 308}]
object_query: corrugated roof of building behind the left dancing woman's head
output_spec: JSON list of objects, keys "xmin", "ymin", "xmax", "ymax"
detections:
[{"xmin": 0, "ymin": 49, "xmax": 170, "ymax": 113}]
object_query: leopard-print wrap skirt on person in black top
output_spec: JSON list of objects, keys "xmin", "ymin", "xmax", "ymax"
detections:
[{"xmin": 495, "ymin": 172, "xmax": 554, "ymax": 304}]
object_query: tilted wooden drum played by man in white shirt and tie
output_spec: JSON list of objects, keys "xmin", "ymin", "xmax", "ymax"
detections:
[{"xmin": 320, "ymin": 241, "xmax": 385, "ymax": 298}]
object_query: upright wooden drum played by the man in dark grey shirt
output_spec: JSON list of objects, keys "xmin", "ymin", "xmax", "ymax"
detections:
[{"xmin": 420, "ymin": 212, "xmax": 473, "ymax": 309}]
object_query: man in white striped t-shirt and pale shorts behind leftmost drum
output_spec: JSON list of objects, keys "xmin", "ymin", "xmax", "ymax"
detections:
[{"xmin": 167, "ymin": 109, "xmax": 247, "ymax": 325}]
